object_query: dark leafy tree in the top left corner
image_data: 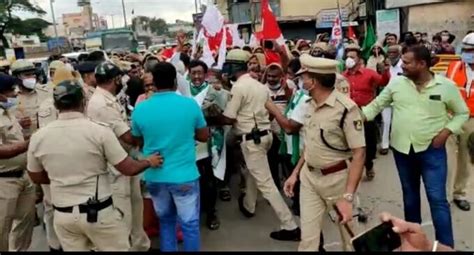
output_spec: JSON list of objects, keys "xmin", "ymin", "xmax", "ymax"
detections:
[{"xmin": 0, "ymin": 0, "xmax": 46, "ymax": 54}]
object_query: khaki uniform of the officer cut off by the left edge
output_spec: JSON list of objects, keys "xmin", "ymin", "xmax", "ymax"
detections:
[{"xmin": 0, "ymin": 108, "xmax": 36, "ymax": 251}]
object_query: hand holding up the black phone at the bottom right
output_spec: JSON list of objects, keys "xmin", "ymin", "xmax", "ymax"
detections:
[{"xmin": 380, "ymin": 213, "xmax": 433, "ymax": 252}]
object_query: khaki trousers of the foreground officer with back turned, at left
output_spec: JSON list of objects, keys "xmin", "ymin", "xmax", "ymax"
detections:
[{"xmin": 54, "ymin": 206, "xmax": 130, "ymax": 252}]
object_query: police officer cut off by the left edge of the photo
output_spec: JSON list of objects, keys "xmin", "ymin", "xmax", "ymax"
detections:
[{"xmin": 0, "ymin": 74, "xmax": 36, "ymax": 251}]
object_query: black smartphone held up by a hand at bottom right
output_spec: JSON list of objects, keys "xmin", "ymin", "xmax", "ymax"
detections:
[{"xmin": 351, "ymin": 222, "xmax": 402, "ymax": 252}]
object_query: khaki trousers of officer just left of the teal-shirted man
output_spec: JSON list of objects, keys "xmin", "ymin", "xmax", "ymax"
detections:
[{"xmin": 112, "ymin": 175, "xmax": 151, "ymax": 251}]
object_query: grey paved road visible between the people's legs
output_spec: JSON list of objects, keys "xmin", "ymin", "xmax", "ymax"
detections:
[{"xmin": 31, "ymin": 151, "xmax": 474, "ymax": 251}]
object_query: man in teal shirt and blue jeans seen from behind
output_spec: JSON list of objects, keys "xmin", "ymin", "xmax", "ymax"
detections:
[{"xmin": 132, "ymin": 63, "xmax": 209, "ymax": 252}]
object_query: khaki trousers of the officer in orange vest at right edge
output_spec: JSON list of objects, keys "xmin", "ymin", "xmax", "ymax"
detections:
[{"xmin": 446, "ymin": 118, "xmax": 474, "ymax": 201}]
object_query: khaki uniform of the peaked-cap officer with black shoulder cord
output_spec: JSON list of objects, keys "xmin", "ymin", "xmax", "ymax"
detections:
[{"xmin": 298, "ymin": 90, "xmax": 365, "ymax": 251}]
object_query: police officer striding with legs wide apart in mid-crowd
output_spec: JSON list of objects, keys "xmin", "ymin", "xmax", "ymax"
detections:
[{"xmin": 222, "ymin": 49, "xmax": 300, "ymax": 241}]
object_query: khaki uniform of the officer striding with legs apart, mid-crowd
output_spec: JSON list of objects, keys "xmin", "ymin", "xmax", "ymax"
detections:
[{"xmin": 224, "ymin": 74, "xmax": 297, "ymax": 230}]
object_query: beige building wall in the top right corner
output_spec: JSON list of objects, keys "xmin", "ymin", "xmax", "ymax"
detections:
[{"xmin": 385, "ymin": 0, "xmax": 474, "ymax": 43}]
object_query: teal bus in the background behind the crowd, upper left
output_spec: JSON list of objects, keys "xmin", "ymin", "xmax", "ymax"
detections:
[{"xmin": 85, "ymin": 28, "xmax": 138, "ymax": 52}]
